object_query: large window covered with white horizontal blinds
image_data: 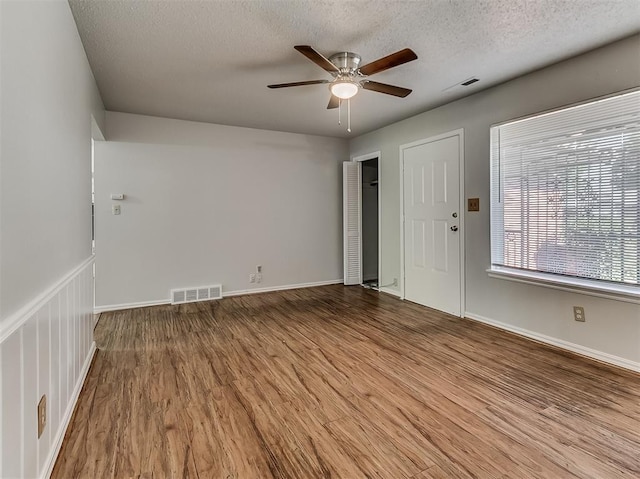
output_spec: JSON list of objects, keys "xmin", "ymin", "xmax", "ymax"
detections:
[{"xmin": 491, "ymin": 91, "xmax": 640, "ymax": 294}]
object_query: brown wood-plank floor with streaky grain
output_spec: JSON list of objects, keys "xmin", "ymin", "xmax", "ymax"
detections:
[{"xmin": 53, "ymin": 286, "xmax": 640, "ymax": 479}]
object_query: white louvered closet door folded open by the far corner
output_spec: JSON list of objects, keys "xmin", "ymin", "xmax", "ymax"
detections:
[{"xmin": 342, "ymin": 161, "xmax": 362, "ymax": 284}]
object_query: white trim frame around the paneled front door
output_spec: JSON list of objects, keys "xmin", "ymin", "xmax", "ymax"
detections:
[{"xmin": 399, "ymin": 128, "xmax": 466, "ymax": 318}]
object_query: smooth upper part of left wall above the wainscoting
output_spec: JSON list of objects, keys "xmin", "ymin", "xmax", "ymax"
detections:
[{"xmin": 0, "ymin": 1, "xmax": 102, "ymax": 322}]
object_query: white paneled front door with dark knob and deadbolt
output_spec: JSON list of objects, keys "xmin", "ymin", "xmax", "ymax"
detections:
[{"xmin": 401, "ymin": 134, "xmax": 462, "ymax": 316}]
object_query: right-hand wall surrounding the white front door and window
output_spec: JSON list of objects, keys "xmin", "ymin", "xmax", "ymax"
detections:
[{"xmin": 350, "ymin": 36, "xmax": 640, "ymax": 368}]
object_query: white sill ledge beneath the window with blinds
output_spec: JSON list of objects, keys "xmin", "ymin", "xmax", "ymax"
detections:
[{"xmin": 487, "ymin": 266, "xmax": 640, "ymax": 304}]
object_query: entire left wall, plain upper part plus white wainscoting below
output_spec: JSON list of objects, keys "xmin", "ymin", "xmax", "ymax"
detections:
[{"xmin": 0, "ymin": 1, "xmax": 104, "ymax": 478}]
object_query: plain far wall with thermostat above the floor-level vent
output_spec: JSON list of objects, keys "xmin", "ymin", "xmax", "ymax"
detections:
[{"xmin": 95, "ymin": 112, "xmax": 348, "ymax": 309}]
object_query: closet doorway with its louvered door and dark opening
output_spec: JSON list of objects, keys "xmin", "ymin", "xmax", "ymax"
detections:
[{"xmin": 343, "ymin": 152, "xmax": 380, "ymax": 290}]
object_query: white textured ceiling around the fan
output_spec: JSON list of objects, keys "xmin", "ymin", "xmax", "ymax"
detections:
[{"xmin": 70, "ymin": 0, "xmax": 640, "ymax": 137}]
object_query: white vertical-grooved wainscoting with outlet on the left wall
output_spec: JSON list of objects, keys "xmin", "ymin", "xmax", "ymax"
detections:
[{"xmin": 0, "ymin": 258, "xmax": 95, "ymax": 479}]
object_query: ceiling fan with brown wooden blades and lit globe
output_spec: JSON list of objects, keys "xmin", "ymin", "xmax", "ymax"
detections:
[{"xmin": 268, "ymin": 45, "xmax": 418, "ymax": 109}]
